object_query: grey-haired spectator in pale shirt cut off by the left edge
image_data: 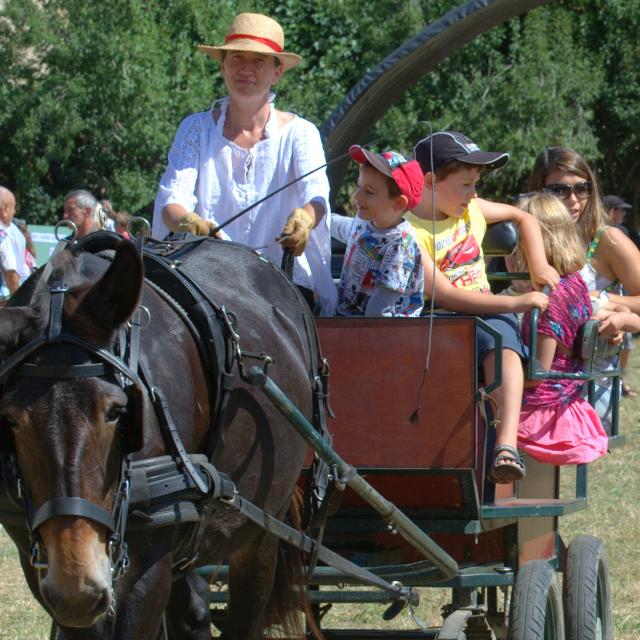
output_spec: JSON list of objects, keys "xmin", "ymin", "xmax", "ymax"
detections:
[{"xmin": 0, "ymin": 187, "xmax": 31, "ymax": 300}]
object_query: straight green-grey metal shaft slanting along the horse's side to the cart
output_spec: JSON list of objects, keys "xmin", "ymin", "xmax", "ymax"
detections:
[{"xmin": 249, "ymin": 367, "xmax": 458, "ymax": 580}]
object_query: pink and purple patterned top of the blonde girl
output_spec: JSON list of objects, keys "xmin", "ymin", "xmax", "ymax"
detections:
[{"xmin": 522, "ymin": 272, "xmax": 591, "ymax": 406}]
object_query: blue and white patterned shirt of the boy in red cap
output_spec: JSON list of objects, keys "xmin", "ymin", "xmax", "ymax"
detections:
[{"xmin": 337, "ymin": 216, "xmax": 424, "ymax": 316}]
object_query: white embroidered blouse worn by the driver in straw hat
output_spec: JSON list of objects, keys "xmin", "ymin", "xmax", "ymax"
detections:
[{"xmin": 152, "ymin": 98, "xmax": 336, "ymax": 315}]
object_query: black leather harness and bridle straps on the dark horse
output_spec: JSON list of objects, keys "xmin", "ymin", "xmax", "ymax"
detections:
[{"xmin": 0, "ymin": 232, "xmax": 418, "ymax": 621}]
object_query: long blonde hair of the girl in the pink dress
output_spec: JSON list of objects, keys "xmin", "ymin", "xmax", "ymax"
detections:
[{"xmin": 516, "ymin": 192, "xmax": 585, "ymax": 276}]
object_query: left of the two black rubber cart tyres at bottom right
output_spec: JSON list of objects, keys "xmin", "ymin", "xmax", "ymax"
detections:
[{"xmin": 507, "ymin": 560, "xmax": 564, "ymax": 640}]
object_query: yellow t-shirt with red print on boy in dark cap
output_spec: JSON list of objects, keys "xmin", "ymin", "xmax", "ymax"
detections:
[{"xmin": 405, "ymin": 200, "xmax": 491, "ymax": 293}]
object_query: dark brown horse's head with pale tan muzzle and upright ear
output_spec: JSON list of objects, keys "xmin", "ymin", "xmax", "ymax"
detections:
[{"xmin": 0, "ymin": 242, "xmax": 143, "ymax": 627}]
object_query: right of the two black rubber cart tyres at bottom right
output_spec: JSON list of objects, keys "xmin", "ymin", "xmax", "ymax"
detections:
[{"xmin": 563, "ymin": 536, "xmax": 613, "ymax": 640}]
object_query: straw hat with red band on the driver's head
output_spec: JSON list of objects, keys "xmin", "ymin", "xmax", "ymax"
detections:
[{"xmin": 198, "ymin": 13, "xmax": 302, "ymax": 69}]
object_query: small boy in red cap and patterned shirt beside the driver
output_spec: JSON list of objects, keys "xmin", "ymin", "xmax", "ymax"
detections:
[{"xmin": 331, "ymin": 145, "xmax": 424, "ymax": 316}]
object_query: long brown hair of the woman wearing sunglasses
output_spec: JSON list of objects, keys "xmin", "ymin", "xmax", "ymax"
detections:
[{"xmin": 529, "ymin": 147, "xmax": 608, "ymax": 247}]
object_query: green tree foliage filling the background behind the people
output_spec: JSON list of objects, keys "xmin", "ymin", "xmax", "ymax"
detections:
[{"xmin": 0, "ymin": 0, "xmax": 640, "ymax": 222}]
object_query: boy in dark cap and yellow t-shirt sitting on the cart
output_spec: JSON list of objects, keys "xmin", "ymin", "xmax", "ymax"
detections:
[{"xmin": 407, "ymin": 131, "xmax": 560, "ymax": 483}]
